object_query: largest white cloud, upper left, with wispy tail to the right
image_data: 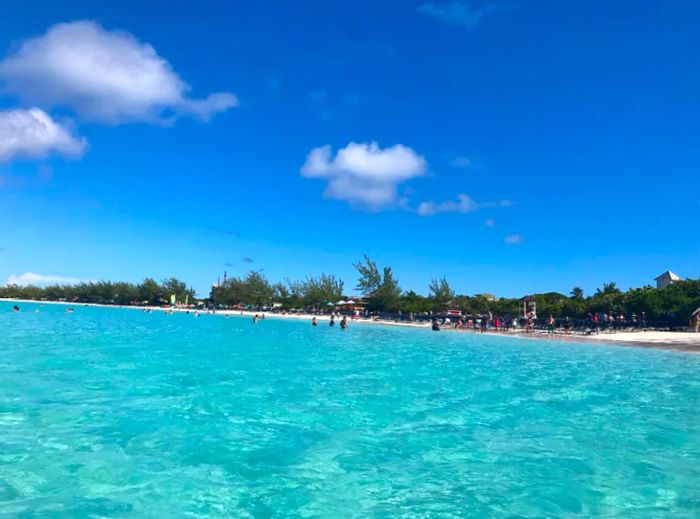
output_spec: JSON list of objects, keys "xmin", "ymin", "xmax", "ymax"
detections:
[{"xmin": 0, "ymin": 20, "xmax": 238, "ymax": 124}]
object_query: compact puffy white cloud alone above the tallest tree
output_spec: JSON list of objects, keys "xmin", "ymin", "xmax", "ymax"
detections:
[{"xmin": 301, "ymin": 142, "xmax": 427, "ymax": 210}]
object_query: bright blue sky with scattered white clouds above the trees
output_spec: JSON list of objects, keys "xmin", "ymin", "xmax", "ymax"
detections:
[{"xmin": 0, "ymin": 0, "xmax": 700, "ymax": 297}]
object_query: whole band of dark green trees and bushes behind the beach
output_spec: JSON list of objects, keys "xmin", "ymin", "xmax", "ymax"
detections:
[{"xmin": 0, "ymin": 256, "xmax": 700, "ymax": 325}]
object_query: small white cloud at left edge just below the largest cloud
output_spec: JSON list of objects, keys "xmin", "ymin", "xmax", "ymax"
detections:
[{"xmin": 0, "ymin": 108, "xmax": 87, "ymax": 162}]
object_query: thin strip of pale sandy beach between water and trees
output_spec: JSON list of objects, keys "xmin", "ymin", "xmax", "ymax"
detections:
[{"xmin": 0, "ymin": 298, "xmax": 700, "ymax": 355}]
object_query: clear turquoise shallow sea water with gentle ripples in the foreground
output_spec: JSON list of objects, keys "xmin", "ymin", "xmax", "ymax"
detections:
[{"xmin": 0, "ymin": 302, "xmax": 700, "ymax": 518}]
